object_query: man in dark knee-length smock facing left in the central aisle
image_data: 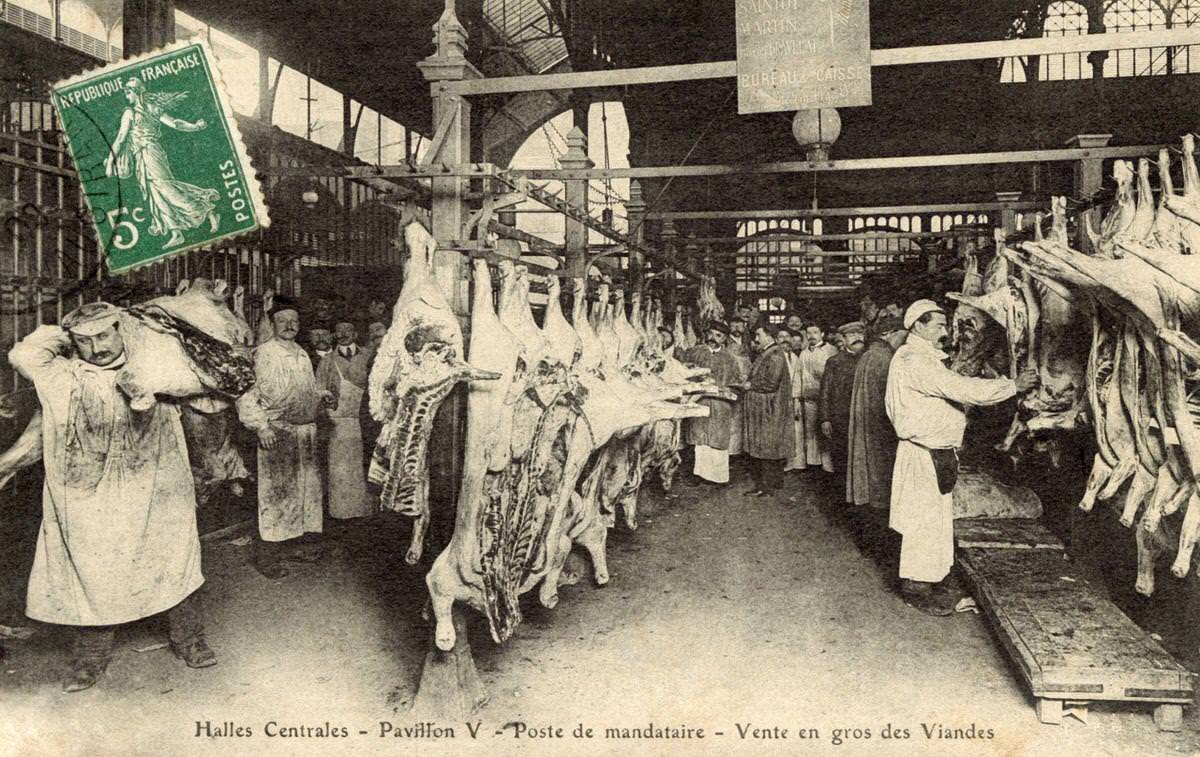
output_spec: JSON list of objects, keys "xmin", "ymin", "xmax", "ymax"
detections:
[{"xmin": 743, "ymin": 323, "xmax": 796, "ymax": 497}]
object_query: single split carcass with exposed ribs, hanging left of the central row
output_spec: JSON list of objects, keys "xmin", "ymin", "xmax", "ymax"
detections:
[{"xmin": 368, "ymin": 221, "xmax": 498, "ymax": 565}]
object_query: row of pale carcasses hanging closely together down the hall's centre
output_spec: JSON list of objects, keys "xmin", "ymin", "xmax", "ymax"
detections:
[{"xmin": 426, "ymin": 262, "xmax": 718, "ymax": 649}]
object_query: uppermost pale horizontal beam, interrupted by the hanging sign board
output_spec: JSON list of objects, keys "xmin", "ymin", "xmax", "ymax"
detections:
[{"xmin": 445, "ymin": 26, "xmax": 1200, "ymax": 96}]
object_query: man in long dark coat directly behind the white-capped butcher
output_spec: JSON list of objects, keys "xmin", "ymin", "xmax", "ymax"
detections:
[{"xmin": 846, "ymin": 316, "xmax": 907, "ymax": 511}]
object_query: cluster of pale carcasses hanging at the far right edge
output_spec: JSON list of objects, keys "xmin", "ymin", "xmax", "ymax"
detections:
[{"xmin": 1014, "ymin": 143, "xmax": 1200, "ymax": 594}]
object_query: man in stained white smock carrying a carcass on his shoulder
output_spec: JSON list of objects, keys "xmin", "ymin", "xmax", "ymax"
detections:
[{"xmin": 8, "ymin": 302, "xmax": 216, "ymax": 691}]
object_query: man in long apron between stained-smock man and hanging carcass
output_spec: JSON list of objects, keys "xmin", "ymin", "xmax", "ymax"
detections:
[{"xmin": 317, "ymin": 320, "xmax": 376, "ymax": 527}]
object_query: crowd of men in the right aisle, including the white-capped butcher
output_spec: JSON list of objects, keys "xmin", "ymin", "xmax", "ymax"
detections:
[{"xmin": 679, "ymin": 292, "xmax": 1037, "ymax": 615}]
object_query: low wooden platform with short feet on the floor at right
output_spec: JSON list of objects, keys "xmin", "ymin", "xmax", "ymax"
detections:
[{"xmin": 955, "ymin": 519, "xmax": 1195, "ymax": 731}]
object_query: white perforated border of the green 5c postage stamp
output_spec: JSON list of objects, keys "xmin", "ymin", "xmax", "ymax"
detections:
[{"xmin": 50, "ymin": 37, "xmax": 271, "ymax": 274}]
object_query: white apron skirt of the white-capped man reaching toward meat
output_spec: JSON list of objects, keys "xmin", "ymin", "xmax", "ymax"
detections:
[{"xmin": 888, "ymin": 439, "xmax": 954, "ymax": 583}]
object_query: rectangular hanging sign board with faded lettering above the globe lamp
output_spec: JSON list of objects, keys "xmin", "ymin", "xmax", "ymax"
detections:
[{"xmin": 736, "ymin": 0, "xmax": 871, "ymax": 114}]
